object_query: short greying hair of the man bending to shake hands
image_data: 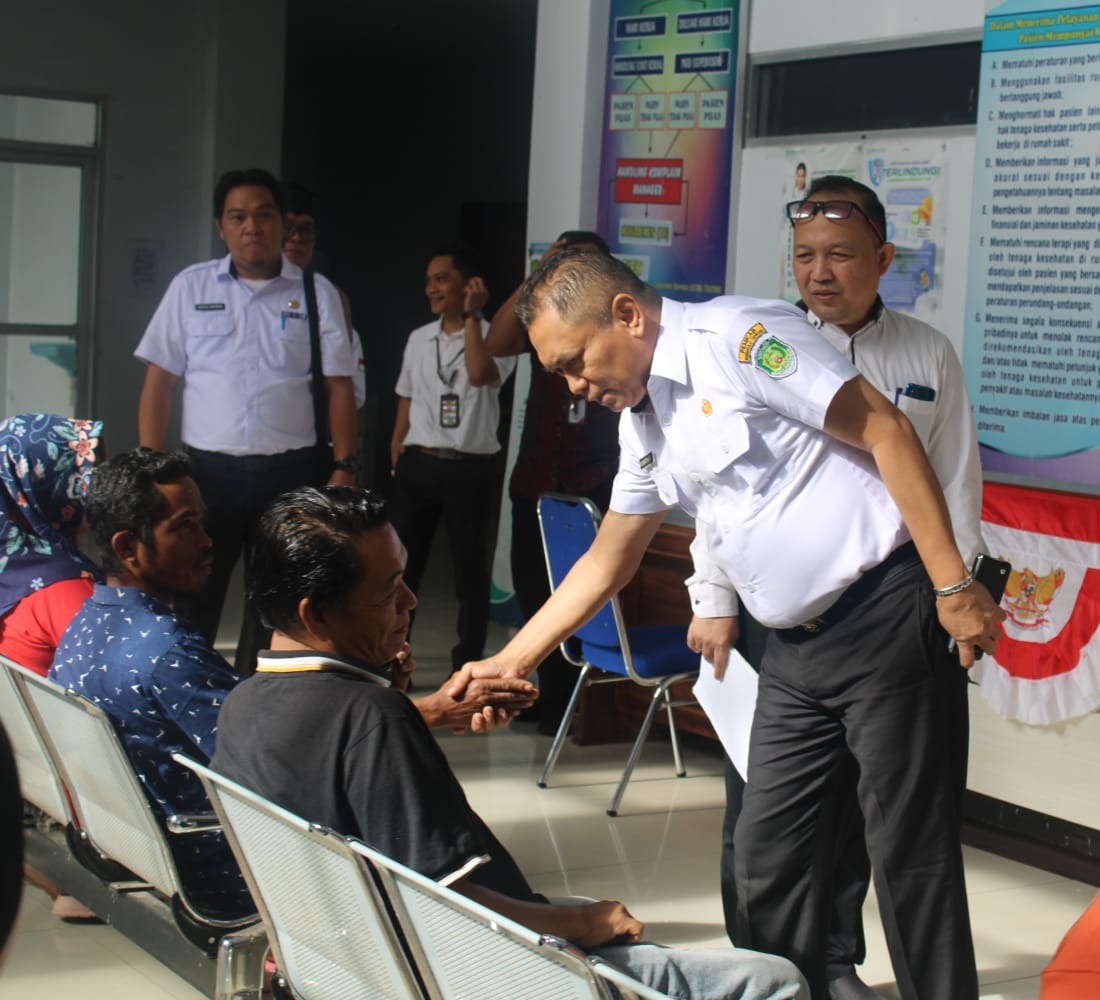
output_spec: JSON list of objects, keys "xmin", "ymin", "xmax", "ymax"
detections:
[{"xmin": 516, "ymin": 246, "xmax": 657, "ymax": 327}]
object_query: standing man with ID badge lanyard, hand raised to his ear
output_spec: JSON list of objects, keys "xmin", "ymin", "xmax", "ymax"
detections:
[{"xmin": 389, "ymin": 243, "xmax": 516, "ymax": 670}]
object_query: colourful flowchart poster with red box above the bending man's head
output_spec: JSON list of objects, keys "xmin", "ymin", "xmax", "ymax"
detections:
[{"xmin": 598, "ymin": 0, "xmax": 740, "ymax": 301}]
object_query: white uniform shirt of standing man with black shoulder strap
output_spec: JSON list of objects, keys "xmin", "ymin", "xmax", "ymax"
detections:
[{"xmin": 134, "ymin": 254, "xmax": 355, "ymax": 455}]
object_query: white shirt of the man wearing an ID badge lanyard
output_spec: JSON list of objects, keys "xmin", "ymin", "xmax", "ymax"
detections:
[{"xmin": 396, "ymin": 319, "xmax": 516, "ymax": 454}]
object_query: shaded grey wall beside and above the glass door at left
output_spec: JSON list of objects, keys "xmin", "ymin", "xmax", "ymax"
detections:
[{"xmin": 0, "ymin": 0, "xmax": 286, "ymax": 449}]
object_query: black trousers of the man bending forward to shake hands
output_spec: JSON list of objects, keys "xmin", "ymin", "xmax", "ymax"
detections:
[{"xmin": 734, "ymin": 550, "xmax": 978, "ymax": 1000}]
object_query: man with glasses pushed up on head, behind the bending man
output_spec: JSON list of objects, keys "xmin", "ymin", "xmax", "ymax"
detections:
[{"xmin": 689, "ymin": 175, "xmax": 983, "ymax": 1000}]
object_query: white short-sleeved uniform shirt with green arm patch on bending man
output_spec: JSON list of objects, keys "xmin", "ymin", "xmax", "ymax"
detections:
[{"xmin": 611, "ymin": 296, "xmax": 910, "ymax": 628}]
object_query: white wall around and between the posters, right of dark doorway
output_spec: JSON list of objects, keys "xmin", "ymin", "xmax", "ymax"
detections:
[{"xmin": 528, "ymin": 0, "xmax": 1100, "ymax": 829}]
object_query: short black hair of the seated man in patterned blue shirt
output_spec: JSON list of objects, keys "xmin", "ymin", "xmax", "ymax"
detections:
[{"xmin": 85, "ymin": 448, "xmax": 191, "ymax": 574}]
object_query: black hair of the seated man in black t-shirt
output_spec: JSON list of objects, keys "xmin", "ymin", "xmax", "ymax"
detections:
[{"xmin": 249, "ymin": 486, "xmax": 388, "ymax": 636}]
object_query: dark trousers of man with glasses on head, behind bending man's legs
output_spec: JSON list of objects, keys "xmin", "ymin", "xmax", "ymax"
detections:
[{"xmin": 721, "ymin": 606, "xmax": 871, "ymax": 980}]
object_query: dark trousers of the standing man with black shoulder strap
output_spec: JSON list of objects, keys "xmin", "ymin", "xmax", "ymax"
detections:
[{"xmin": 177, "ymin": 448, "xmax": 323, "ymax": 677}]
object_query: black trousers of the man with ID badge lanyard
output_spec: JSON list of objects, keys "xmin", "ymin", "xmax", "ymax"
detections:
[{"xmin": 389, "ymin": 447, "xmax": 494, "ymax": 670}]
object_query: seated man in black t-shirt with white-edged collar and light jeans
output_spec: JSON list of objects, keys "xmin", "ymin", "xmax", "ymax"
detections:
[{"xmin": 212, "ymin": 486, "xmax": 804, "ymax": 1000}]
